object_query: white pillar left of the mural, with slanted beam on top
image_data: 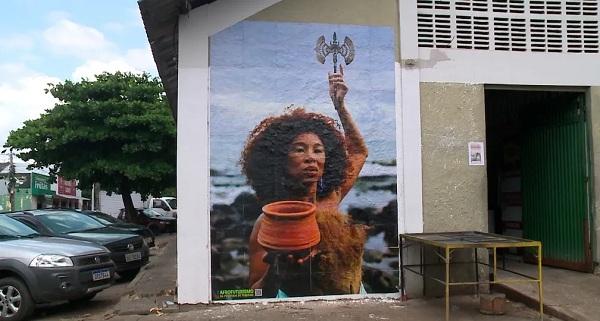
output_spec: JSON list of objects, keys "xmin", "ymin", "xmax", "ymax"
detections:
[{"xmin": 177, "ymin": 0, "xmax": 279, "ymax": 304}]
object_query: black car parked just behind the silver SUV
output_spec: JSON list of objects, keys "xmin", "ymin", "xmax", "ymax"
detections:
[{"xmin": 10, "ymin": 209, "xmax": 149, "ymax": 279}]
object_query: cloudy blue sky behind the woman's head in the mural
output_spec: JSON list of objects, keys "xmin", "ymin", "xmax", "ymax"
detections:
[{"xmin": 210, "ymin": 21, "xmax": 396, "ymax": 173}]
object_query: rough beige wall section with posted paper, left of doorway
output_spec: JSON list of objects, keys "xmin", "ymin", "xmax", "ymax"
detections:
[{"xmin": 421, "ymin": 83, "xmax": 488, "ymax": 232}]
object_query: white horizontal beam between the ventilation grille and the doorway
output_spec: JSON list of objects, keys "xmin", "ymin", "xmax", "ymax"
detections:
[{"xmin": 417, "ymin": 48, "xmax": 600, "ymax": 86}]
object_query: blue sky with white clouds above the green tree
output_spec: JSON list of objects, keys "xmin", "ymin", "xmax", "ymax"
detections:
[{"xmin": 0, "ymin": 0, "xmax": 158, "ymax": 161}]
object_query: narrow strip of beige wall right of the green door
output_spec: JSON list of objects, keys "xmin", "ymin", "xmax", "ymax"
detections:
[{"xmin": 588, "ymin": 87, "xmax": 600, "ymax": 262}]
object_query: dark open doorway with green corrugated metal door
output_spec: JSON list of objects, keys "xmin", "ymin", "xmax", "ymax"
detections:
[{"xmin": 485, "ymin": 89, "xmax": 593, "ymax": 272}]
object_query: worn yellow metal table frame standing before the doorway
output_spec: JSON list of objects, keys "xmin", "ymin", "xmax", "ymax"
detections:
[{"xmin": 400, "ymin": 231, "xmax": 544, "ymax": 321}]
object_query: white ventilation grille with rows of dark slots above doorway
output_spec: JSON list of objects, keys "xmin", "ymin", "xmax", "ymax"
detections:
[{"xmin": 417, "ymin": 0, "xmax": 600, "ymax": 53}]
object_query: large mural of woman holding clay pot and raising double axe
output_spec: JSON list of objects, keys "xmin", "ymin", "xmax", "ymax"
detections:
[{"xmin": 210, "ymin": 21, "xmax": 398, "ymax": 300}]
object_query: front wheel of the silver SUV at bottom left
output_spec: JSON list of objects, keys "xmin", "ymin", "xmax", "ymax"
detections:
[{"xmin": 0, "ymin": 277, "xmax": 35, "ymax": 321}]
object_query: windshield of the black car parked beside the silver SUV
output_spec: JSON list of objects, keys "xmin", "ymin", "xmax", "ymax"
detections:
[{"xmin": 36, "ymin": 212, "xmax": 104, "ymax": 234}]
